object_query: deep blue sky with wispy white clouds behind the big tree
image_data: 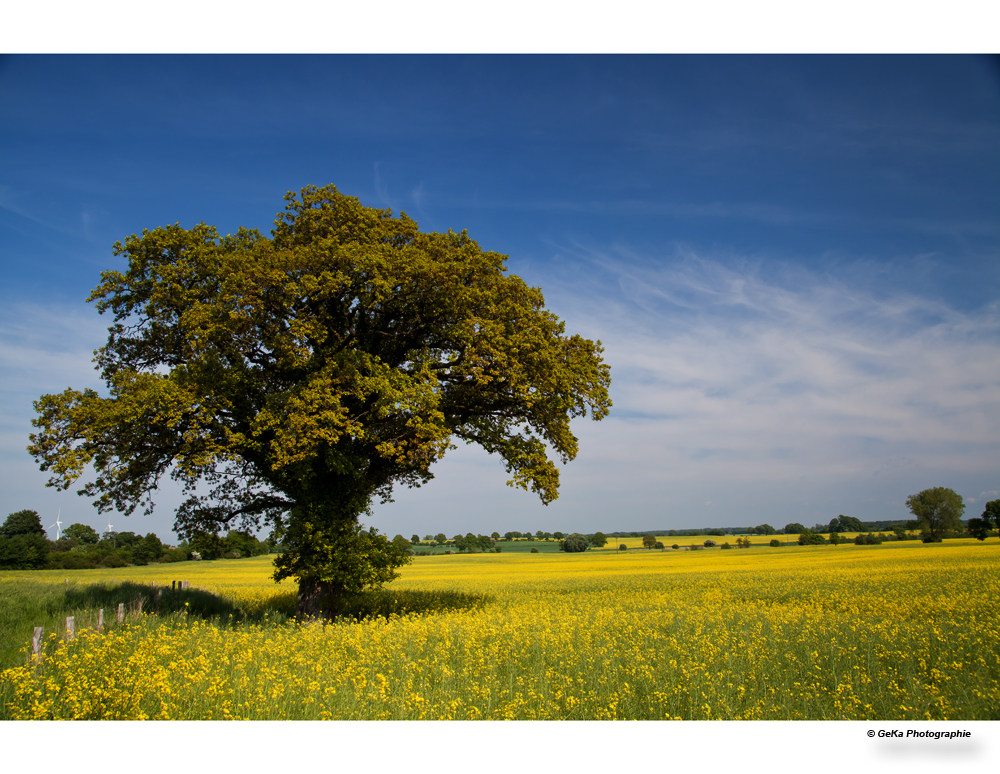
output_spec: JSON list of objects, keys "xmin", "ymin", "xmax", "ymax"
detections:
[{"xmin": 0, "ymin": 55, "xmax": 1000, "ymax": 537}]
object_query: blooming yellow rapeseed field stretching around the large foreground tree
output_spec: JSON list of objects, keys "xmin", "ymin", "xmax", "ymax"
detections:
[{"xmin": 0, "ymin": 540, "xmax": 1000, "ymax": 720}]
